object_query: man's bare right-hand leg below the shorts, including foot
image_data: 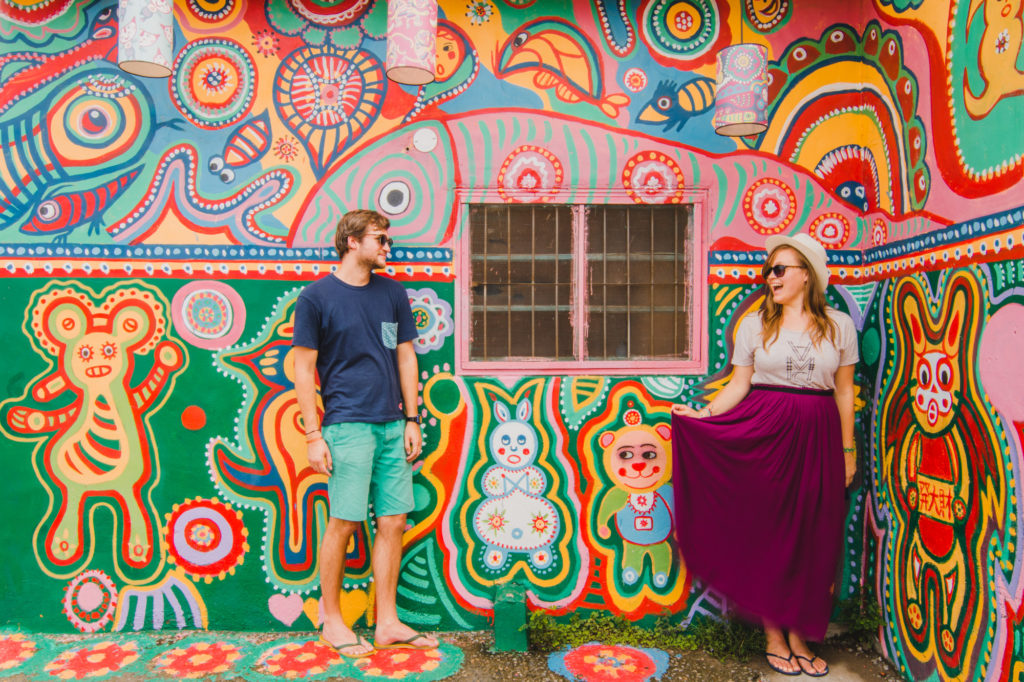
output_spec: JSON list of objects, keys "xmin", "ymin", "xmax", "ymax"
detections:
[{"xmin": 373, "ymin": 514, "xmax": 437, "ymax": 648}]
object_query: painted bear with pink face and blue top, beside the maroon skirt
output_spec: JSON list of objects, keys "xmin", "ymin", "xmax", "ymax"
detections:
[{"xmin": 597, "ymin": 410, "xmax": 674, "ymax": 588}]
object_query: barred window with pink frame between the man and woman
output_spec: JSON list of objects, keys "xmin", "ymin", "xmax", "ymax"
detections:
[{"xmin": 464, "ymin": 204, "xmax": 698, "ymax": 371}]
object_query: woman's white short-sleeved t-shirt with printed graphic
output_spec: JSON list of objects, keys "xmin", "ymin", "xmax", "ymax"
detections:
[{"xmin": 732, "ymin": 308, "xmax": 859, "ymax": 389}]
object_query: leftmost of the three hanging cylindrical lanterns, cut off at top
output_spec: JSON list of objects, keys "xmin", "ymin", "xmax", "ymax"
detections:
[{"xmin": 118, "ymin": 0, "xmax": 174, "ymax": 78}]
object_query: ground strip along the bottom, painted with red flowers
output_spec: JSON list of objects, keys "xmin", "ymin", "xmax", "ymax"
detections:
[{"xmin": 0, "ymin": 631, "xmax": 900, "ymax": 682}]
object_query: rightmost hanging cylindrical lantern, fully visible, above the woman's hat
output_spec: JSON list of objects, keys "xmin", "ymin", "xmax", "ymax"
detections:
[{"xmin": 715, "ymin": 43, "xmax": 768, "ymax": 137}]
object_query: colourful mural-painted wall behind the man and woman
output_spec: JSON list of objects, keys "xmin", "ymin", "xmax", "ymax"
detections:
[{"xmin": 0, "ymin": 0, "xmax": 1024, "ymax": 680}]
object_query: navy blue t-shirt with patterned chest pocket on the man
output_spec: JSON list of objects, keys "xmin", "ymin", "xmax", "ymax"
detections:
[{"xmin": 292, "ymin": 273, "xmax": 417, "ymax": 425}]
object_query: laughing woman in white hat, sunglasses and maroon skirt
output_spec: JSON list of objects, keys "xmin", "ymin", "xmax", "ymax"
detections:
[{"xmin": 672, "ymin": 235, "xmax": 858, "ymax": 677}]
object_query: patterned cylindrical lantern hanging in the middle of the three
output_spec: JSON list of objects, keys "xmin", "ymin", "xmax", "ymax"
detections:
[{"xmin": 385, "ymin": 0, "xmax": 437, "ymax": 85}]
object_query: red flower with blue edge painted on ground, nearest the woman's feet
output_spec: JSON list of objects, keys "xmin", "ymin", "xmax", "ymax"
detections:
[{"xmin": 548, "ymin": 642, "xmax": 669, "ymax": 682}]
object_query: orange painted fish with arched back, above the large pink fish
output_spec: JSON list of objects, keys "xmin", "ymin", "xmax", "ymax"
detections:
[{"xmin": 495, "ymin": 18, "xmax": 630, "ymax": 118}]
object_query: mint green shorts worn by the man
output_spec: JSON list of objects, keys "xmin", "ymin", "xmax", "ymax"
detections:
[{"xmin": 324, "ymin": 420, "xmax": 414, "ymax": 521}]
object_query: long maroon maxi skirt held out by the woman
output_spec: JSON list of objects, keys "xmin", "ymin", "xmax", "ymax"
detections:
[{"xmin": 672, "ymin": 385, "xmax": 846, "ymax": 640}]
